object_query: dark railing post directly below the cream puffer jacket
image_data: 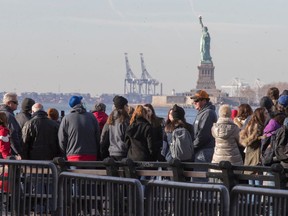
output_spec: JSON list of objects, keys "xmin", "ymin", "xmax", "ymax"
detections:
[{"xmin": 219, "ymin": 161, "xmax": 239, "ymax": 191}]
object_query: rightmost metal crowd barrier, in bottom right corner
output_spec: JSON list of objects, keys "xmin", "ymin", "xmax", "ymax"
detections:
[{"xmin": 230, "ymin": 186, "xmax": 288, "ymax": 216}]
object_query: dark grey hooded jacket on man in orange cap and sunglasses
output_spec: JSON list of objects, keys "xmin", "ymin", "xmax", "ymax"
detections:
[{"xmin": 193, "ymin": 102, "xmax": 217, "ymax": 153}]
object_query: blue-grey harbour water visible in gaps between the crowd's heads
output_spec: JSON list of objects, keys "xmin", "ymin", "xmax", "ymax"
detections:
[{"xmin": 43, "ymin": 103, "xmax": 197, "ymax": 124}]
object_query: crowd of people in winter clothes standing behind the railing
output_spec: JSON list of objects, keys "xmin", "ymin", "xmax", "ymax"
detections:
[{"xmin": 0, "ymin": 87, "xmax": 288, "ymax": 184}]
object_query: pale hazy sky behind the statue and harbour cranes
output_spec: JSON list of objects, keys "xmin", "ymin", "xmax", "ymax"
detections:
[{"xmin": 0, "ymin": 0, "xmax": 288, "ymax": 95}]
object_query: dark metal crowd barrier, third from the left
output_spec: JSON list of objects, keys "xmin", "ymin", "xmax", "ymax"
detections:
[{"xmin": 145, "ymin": 181, "xmax": 229, "ymax": 216}]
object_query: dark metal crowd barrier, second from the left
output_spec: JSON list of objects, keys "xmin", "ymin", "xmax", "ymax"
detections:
[{"xmin": 57, "ymin": 172, "xmax": 144, "ymax": 216}]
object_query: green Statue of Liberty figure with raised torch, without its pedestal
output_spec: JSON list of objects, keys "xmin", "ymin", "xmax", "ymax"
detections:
[{"xmin": 199, "ymin": 16, "xmax": 212, "ymax": 63}]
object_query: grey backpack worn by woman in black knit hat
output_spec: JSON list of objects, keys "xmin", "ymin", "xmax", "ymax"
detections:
[{"xmin": 170, "ymin": 127, "xmax": 194, "ymax": 161}]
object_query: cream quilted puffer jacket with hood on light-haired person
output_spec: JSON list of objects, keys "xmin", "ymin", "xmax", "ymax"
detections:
[{"xmin": 212, "ymin": 117, "xmax": 243, "ymax": 165}]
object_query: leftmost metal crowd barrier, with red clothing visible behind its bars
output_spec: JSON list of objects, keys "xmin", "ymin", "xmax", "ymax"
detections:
[{"xmin": 0, "ymin": 160, "xmax": 58, "ymax": 215}]
